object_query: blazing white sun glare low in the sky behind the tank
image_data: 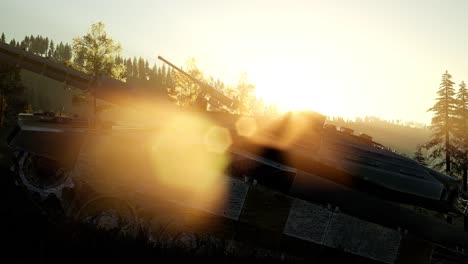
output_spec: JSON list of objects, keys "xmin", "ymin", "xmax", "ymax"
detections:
[{"xmin": 250, "ymin": 58, "xmax": 359, "ymax": 118}]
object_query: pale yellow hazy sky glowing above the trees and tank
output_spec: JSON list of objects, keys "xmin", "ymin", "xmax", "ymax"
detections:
[{"xmin": 0, "ymin": 0, "xmax": 468, "ymax": 123}]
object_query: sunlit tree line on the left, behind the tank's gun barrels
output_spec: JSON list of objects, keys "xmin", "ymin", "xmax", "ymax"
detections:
[{"xmin": 0, "ymin": 22, "xmax": 279, "ymax": 115}]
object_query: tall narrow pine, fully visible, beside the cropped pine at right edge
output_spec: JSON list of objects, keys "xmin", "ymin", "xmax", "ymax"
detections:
[{"xmin": 425, "ymin": 71, "xmax": 456, "ymax": 175}]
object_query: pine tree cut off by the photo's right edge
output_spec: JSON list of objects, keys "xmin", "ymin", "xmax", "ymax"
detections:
[{"xmin": 455, "ymin": 82, "xmax": 468, "ymax": 191}]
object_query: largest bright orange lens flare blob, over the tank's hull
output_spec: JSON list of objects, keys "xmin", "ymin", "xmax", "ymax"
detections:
[{"xmin": 151, "ymin": 110, "xmax": 232, "ymax": 207}]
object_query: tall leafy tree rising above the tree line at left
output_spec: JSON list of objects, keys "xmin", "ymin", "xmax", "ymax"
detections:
[{"xmin": 72, "ymin": 22, "xmax": 125, "ymax": 79}]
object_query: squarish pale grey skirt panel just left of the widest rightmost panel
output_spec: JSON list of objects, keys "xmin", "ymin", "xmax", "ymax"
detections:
[{"xmin": 284, "ymin": 199, "xmax": 332, "ymax": 244}]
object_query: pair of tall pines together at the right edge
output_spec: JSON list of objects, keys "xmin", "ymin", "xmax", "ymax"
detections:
[{"xmin": 415, "ymin": 71, "xmax": 468, "ymax": 191}]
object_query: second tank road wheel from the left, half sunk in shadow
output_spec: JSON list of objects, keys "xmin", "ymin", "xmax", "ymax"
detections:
[{"xmin": 75, "ymin": 196, "xmax": 140, "ymax": 238}]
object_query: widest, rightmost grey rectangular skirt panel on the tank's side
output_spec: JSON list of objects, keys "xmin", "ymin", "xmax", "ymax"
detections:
[{"xmin": 324, "ymin": 214, "xmax": 401, "ymax": 263}]
